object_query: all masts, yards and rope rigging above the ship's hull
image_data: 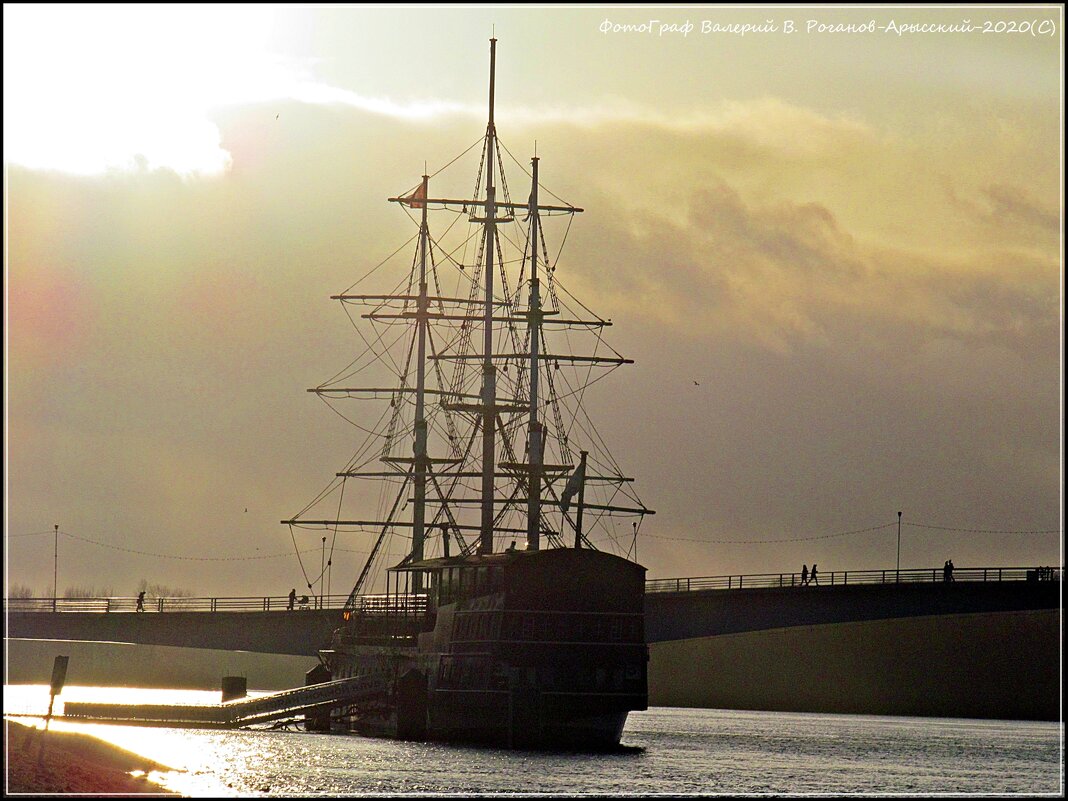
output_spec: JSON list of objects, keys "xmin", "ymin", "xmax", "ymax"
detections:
[{"xmin": 282, "ymin": 40, "xmax": 654, "ymax": 608}]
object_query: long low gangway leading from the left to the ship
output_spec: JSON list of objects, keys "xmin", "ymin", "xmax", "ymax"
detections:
[{"xmin": 58, "ymin": 676, "xmax": 388, "ymax": 728}]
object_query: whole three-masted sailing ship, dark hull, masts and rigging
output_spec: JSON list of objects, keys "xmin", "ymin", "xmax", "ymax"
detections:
[{"xmin": 282, "ymin": 40, "xmax": 654, "ymax": 749}]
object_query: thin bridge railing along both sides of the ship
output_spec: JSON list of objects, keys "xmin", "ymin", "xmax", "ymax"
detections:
[{"xmin": 3, "ymin": 567, "xmax": 1063, "ymax": 616}]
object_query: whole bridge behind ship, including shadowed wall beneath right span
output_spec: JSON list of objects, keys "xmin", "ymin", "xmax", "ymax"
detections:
[{"xmin": 5, "ymin": 567, "xmax": 1062, "ymax": 720}]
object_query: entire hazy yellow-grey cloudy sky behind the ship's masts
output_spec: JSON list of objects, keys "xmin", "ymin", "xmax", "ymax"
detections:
[{"xmin": 3, "ymin": 4, "xmax": 1064, "ymax": 595}]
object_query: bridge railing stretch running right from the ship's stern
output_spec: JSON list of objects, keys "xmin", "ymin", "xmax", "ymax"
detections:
[{"xmin": 645, "ymin": 567, "xmax": 1062, "ymax": 593}]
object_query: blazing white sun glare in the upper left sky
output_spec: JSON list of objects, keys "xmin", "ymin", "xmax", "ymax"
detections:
[{"xmin": 4, "ymin": 5, "xmax": 293, "ymax": 174}]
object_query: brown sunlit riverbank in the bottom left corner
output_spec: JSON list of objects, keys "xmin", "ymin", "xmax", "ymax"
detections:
[{"xmin": 3, "ymin": 718, "xmax": 177, "ymax": 796}]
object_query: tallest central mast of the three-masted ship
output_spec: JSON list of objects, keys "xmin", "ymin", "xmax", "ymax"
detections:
[{"xmin": 478, "ymin": 38, "xmax": 497, "ymax": 553}]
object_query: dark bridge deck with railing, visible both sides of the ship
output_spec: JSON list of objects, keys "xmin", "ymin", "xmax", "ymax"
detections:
[{"xmin": 5, "ymin": 567, "xmax": 1062, "ymax": 658}]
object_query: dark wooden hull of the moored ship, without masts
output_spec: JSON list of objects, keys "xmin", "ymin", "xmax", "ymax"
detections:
[{"xmin": 319, "ymin": 548, "xmax": 648, "ymax": 750}]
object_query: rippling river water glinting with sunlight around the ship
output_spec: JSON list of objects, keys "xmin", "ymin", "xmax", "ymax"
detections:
[{"xmin": 4, "ymin": 685, "xmax": 1065, "ymax": 798}]
